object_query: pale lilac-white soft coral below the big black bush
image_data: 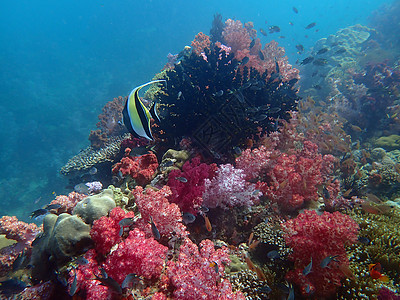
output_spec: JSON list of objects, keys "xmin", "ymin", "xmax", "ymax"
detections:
[{"xmin": 203, "ymin": 164, "xmax": 260, "ymax": 208}]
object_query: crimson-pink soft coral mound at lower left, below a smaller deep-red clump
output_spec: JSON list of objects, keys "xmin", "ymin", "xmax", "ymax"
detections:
[{"xmin": 105, "ymin": 228, "xmax": 168, "ymax": 284}]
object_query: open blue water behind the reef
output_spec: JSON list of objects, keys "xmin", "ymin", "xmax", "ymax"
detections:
[{"xmin": 0, "ymin": 0, "xmax": 394, "ymax": 220}]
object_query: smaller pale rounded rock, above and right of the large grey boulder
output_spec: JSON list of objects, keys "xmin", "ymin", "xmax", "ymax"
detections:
[{"xmin": 72, "ymin": 189, "xmax": 116, "ymax": 224}]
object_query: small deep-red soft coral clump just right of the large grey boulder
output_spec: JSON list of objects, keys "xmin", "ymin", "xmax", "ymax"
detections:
[{"xmin": 90, "ymin": 207, "xmax": 135, "ymax": 255}]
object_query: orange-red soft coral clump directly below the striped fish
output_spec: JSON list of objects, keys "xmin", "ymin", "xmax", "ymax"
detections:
[{"xmin": 112, "ymin": 148, "xmax": 158, "ymax": 185}]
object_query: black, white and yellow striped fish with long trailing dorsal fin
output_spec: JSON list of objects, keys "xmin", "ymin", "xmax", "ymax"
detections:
[{"xmin": 122, "ymin": 80, "xmax": 166, "ymax": 140}]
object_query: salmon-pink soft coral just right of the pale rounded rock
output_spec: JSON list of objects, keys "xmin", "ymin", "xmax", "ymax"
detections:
[{"xmin": 132, "ymin": 186, "xmax": 188, "ymax": 237}]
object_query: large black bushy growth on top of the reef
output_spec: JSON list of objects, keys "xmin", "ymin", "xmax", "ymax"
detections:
[{"xmin": 153, "ymin": 46, "xmax": 299, "ymax": 158}]
